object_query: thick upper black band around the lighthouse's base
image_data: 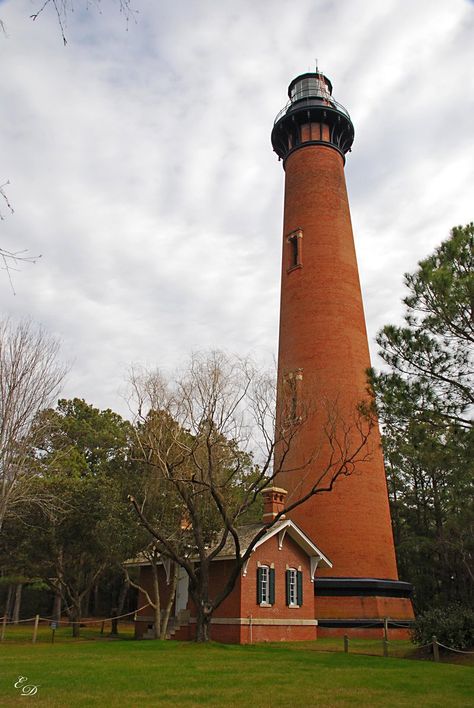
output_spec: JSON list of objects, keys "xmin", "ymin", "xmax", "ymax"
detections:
[{"xmin": 314, "ymin": 578, "xmax": 413, "ymax": 598}]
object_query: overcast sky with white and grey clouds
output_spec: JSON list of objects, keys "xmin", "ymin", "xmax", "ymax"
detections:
[{"xmin": 0, "ymin": 0, "xmax": 474, "ymax": 413}]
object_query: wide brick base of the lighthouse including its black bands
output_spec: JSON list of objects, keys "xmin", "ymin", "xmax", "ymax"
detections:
[{"xmin": 314, "ymin": 577, "xmax": 414, "ymax": 639}]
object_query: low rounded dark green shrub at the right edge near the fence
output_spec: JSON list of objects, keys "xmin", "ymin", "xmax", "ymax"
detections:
[{"xmin": 412, "ymin": 604, "xmax": 474, "ymax": 650}]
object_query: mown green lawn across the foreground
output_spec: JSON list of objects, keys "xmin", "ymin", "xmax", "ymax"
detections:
[{"xmin": 0, "ymin": 639, "xmax": 474, "ymax": 708}]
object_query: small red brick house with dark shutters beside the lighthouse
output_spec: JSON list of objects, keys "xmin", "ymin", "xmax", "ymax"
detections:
[{"xmin": 131, "ymin": 488, "xmax": 332, "ymax": 644}]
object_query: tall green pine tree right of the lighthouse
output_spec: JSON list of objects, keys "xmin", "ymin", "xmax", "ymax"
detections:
[{"xmin": 371, "ymin": 224, "xmax": 474, "ymax": 609}]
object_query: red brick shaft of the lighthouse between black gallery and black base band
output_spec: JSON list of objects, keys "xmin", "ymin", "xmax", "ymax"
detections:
[{"xmin": 276, "ymin": 145, "xmax": 398, "ymax": 579}]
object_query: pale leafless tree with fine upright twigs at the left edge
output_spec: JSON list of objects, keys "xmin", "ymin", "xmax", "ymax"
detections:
[{"xmin": 0, "ymin": 320, "xmax": 66, "ymax": 531}]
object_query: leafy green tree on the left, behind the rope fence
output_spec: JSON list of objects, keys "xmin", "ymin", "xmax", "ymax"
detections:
[{"xmin": 1, "ymin": 399, "xmax": 137, "ymax": 634}]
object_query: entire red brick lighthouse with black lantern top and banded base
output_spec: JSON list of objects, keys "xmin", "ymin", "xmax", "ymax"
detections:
[{"xmin": 272, "ymin": 69, "xmax": 413, "ymax": 634}]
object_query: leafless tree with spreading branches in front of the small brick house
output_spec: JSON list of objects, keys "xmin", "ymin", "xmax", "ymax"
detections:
[{"xmin": 130, "ymin": 352, "xmax": 374, "ymax": 641}]
